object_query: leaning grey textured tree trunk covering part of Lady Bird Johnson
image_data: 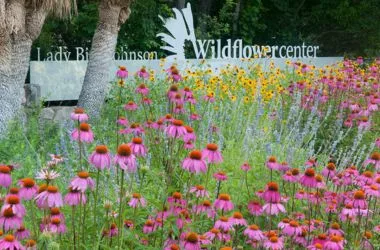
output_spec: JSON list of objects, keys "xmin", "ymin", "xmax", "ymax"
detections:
[{"xmin": 78, "ymin": 1, "xmax": 130, "ymax": 117}]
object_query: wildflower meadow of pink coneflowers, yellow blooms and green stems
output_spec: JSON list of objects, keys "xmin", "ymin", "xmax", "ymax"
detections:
[{"xmin": 0, "ymin": 58, "xmax": 380, "ymax": 250}]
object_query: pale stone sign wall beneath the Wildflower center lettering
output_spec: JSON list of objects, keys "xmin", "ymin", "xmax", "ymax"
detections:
[{"xmin": 30, "ymin": 57, "xmax": 342, "ymax": 101}]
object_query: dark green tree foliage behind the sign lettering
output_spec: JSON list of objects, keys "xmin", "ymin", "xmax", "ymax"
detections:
[{"xmin": 33, "ymin": 0, "xmax": 380, "ymax": 59}]
